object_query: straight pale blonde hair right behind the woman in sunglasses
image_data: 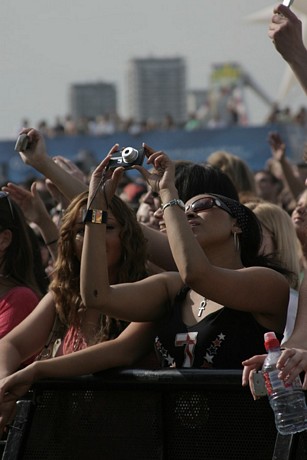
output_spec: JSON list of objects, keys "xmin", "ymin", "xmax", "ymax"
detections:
[{"xmin": 245, "ymin": 201, "xmax": 303, "ymax": 289}]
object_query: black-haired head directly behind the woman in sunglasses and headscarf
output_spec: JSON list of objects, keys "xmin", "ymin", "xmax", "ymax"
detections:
[{"xmin": 175, "ymin": 163, "xmax": 238, "ymax": 202}]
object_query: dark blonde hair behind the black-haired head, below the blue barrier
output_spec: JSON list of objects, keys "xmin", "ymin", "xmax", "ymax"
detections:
[{"xmin": 207, "ymin": 150, "xmax": 256, "ymax": 193}]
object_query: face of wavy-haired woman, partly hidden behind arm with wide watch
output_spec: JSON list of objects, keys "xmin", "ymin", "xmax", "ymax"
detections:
[{"xmin": 75, "ymin": 210, "xmax": 122, "ymax": 271}]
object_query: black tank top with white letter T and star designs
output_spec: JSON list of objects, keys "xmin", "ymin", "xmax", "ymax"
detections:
[{"xmin": 155, "ymin": 288, "xmax": 282, "ymax": 369}]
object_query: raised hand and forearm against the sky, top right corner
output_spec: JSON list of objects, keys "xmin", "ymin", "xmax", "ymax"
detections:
[{"xmin": 269, "ymin": 5, "xmax": 307, "ymax": 93}]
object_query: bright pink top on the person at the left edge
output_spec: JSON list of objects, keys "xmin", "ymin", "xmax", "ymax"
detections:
[{"xmin": 0, "ymin": 286, "xmax": 39, "ymax": 338}]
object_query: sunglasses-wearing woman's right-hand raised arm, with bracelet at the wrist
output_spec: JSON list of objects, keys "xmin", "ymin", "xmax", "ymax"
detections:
[{"xmin": 137, "ymin": 152, "xmax": 289, "ymax": 315}]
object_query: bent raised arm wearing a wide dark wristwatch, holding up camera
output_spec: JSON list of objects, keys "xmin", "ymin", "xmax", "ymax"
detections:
[{"xmin": 80, "ymin": 145, "xmax": 182, "ymax": 321}]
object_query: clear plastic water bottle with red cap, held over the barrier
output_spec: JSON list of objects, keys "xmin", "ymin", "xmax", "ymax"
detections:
[{"xmin": 262, "ymin": 332, "xmax": 307, "ymax": 435}]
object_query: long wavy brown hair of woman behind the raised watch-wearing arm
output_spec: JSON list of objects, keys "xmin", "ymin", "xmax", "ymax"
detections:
[{"xmin": 50, "ymin": 192, "xmax": 147, "ymax": 341}]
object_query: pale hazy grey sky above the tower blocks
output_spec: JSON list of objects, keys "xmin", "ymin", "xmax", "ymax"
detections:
[{"xmin": 0, "ymin": 0, "xmax": 304, "ymax": 140}]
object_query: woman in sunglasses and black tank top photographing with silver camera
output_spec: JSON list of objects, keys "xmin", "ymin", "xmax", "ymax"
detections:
[{"xmin": 0, "ymin": 145, "xmax": 289, "ymax": 401}]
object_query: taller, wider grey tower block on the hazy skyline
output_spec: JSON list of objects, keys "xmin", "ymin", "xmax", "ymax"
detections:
[{"xmin": 128, "ymin": 58, "xmax": 187, "ymax": 123}]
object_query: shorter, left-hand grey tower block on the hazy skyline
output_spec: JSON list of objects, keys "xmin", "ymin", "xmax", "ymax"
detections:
[{"xmin": 69, "ymin": 82, "xmax": 117, "ymax": 119}]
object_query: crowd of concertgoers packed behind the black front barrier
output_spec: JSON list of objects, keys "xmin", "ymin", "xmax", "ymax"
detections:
[{"xmin": 0, "ymin": 0, "xmax": 307, "ymax": 430}]
